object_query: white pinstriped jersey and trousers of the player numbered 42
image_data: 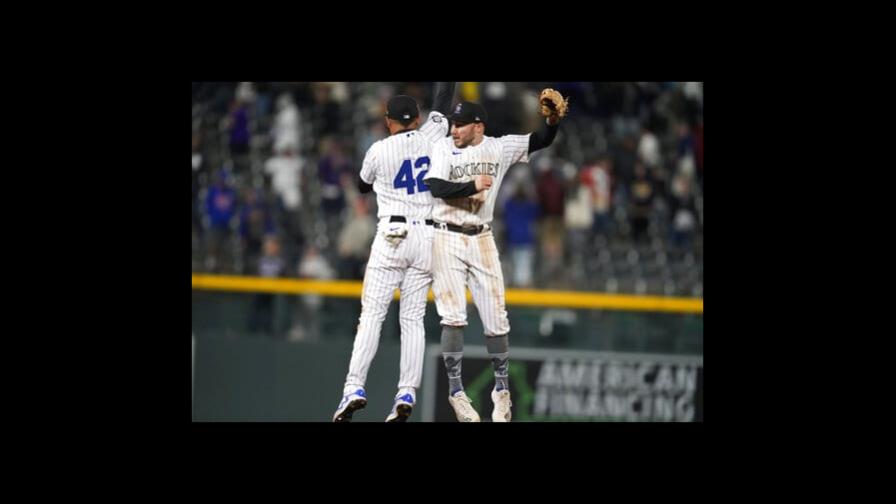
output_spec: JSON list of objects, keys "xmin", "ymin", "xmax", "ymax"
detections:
[{"xmin": 345, "ymin": 111, "xmax": 448, "ymax": 388}]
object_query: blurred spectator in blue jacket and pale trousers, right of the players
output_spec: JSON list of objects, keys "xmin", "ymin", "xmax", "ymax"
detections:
[{"xmin": 504, "ymin": 186, "xmax": 538, "ymax": 287}]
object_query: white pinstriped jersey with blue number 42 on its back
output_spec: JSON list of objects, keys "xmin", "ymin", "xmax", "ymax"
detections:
[{"xmin": 361, "ymin": 111, "xmax": 448, "ymax": 219}]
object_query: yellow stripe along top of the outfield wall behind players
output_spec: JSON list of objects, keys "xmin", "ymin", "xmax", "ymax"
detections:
[{"xmin": 193, "ymin": 273, "xmax": 703, "ymax": 314}]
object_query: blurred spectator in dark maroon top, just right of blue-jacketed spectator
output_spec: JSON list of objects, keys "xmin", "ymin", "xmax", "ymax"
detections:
[{"xmin": 535, "ymin": 156, "xmax": 564, "ymax": 279}]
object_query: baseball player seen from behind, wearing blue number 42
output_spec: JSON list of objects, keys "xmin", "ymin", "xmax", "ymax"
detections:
[{"xmin": 333, "ymin": 82, "xmax": 456, "ymax": 422}]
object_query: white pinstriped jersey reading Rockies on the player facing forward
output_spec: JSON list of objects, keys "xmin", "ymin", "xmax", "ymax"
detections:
[{"xmin": 423, "ymin": 134, "xmax": 530, "ymax": 226}]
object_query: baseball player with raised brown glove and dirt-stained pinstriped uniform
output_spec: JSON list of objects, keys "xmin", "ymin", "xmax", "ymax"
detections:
[{"xmin": 424, "ymin": 89, "xmax": 568, "ymax": 422}]
